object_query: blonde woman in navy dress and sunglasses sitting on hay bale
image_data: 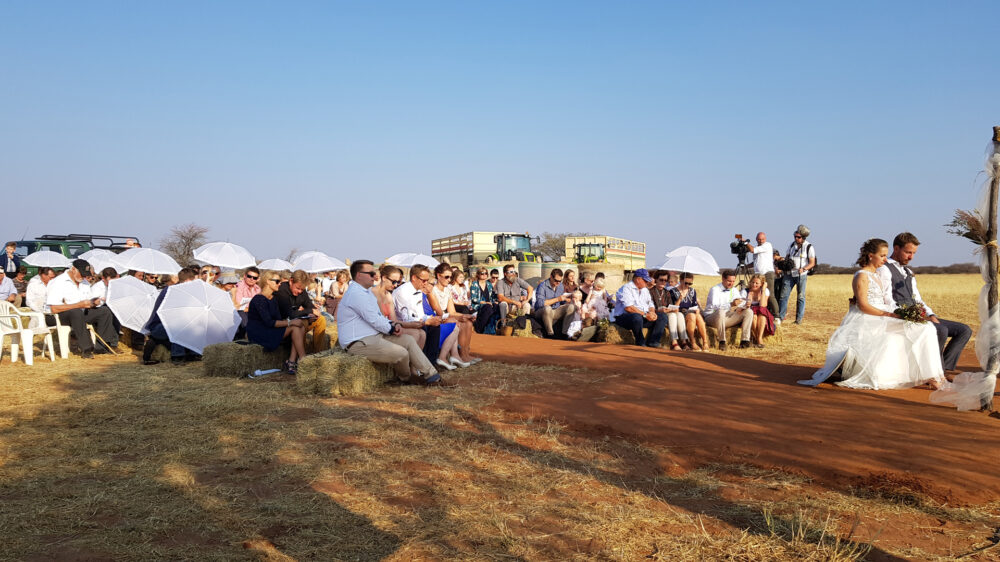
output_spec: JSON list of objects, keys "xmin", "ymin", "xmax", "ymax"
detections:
[{"xmin": 247, "ymin": 268, "xmax": 307, "ymax": 375}]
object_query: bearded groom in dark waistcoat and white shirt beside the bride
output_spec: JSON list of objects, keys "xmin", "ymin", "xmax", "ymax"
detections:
[{"xmin": 879, "ymin": 232, "xmax": 972, "ymax": 371}]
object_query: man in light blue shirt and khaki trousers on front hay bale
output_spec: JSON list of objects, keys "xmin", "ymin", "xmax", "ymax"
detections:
[{"xmin": 337, "ymin": 260, "xmax": 446, "ymax": 386}]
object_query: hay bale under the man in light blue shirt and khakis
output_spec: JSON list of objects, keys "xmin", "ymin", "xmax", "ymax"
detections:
[{"xmin": 295, "ymin": 349, "xmax": 396, "ymax": 396}]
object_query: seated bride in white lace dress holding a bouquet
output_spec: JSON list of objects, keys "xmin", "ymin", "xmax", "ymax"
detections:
[{"xmin": 799, "ymin": 238, "xmax": 945, "ymax": 390}]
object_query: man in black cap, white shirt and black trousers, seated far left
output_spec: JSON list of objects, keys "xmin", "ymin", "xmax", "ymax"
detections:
[{"xmin": 45, "ymin": 259, "xmax": 118, "ymax": 359}]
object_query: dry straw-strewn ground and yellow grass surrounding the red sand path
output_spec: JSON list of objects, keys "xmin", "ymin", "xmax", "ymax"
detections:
[{"xmin": 0, "ymin": 276, "xmax": 1000, "ymax": 560}]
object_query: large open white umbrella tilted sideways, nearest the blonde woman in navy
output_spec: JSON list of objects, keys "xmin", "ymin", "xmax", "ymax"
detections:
[{"xmin": 157, "ymin": 279, "xmax": 240, "ymax": 353}]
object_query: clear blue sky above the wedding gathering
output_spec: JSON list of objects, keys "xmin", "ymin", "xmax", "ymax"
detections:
[{"xmin": 0, "ymin": 0, "xmax": 1000, "ymax": 265}]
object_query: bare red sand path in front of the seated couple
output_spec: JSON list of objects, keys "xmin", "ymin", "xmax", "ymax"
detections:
[{"xmin": 473, "ymin": 336, "xmax": 1000, "ymax": 505}]
